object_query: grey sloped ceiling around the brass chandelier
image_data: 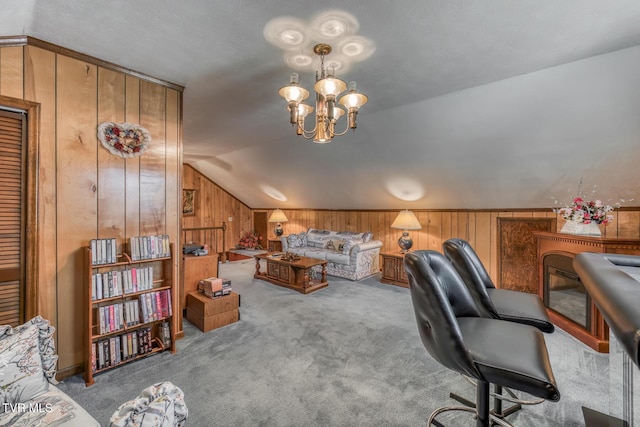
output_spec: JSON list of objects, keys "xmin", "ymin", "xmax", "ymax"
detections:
[{"xmin": 0, "ymin": 0, "xmax": 640, "ymax": 209}]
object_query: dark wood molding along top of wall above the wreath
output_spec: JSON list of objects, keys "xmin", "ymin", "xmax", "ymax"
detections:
[{"xmin": 0, "ymin": 36, "xmax": 184, "ymax": 93}]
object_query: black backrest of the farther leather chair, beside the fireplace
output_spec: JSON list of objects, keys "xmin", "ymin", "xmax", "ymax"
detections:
[{"xmin": 442, "ymin": 238, "xmax": 500, "ymax": 319}]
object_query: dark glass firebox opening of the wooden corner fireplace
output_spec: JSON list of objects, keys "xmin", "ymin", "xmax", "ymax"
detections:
[{"xmin": 542, "ymin": 254, "xmax": 591, "ymax": 330}]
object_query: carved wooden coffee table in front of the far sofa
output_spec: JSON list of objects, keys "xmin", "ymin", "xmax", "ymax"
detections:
[{"xmin": 253, "ymin": 252, "xmax": 329, "ymax": 294}]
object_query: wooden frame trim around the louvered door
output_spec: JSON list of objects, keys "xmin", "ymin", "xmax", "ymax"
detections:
[{"xmin": 0, "ymin": 95, "xmax": 40, "ymax": 320}]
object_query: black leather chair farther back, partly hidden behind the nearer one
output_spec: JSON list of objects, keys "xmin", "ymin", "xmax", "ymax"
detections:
[{"xmin": 442, "ymin": 239, "xmax": 554, "ymax": 332}]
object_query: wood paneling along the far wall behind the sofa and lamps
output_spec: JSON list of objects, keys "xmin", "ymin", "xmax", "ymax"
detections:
[{"xmin": 183, "ymin": 165, "xmax": 640, "ymax": 283}]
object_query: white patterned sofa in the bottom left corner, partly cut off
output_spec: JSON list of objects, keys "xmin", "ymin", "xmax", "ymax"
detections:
[{"xmin": 0, "ymin": 316, "xmax": 100, "ymax": 427}]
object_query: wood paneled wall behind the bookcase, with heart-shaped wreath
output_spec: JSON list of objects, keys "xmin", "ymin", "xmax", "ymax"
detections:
[{"xmin": 0, "ymin": 43, "xmax": 182, "ymax": 376}]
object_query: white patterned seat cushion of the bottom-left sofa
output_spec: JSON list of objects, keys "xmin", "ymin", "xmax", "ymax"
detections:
[{"xmin": 0, "ymin": 385, "xmax": 100, "ymax": 427}]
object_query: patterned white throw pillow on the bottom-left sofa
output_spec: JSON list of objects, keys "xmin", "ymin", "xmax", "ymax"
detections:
[{"xmin": 0, "ymin": 324, "xmax": 49, "ymax": 412}]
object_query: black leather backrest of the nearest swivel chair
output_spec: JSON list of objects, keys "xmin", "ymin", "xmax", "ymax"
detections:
[{"xmin": 404, "ymin": 251, "xmax": 482, "ymax": 378}]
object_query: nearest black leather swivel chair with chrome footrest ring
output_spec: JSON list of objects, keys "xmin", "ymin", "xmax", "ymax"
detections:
[{"xmin": 404, "ymin": 251, "xmax": 560, "ymax": 427}]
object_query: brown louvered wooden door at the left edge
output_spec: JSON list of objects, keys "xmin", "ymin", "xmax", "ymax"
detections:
[{"xmin": 0, "ymin": 110, "xmax": 27, "ymax": 325}]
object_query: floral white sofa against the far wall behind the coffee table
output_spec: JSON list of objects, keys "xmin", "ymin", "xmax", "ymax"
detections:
[{"xmin": 280, "ymin": 228, "xmax": 382, "ymax": 280}]
